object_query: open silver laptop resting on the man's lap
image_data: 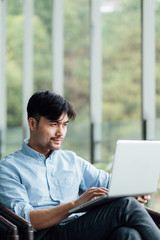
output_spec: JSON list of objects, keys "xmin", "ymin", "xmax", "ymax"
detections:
[{"xmin": 69, "ymin": 140, "xmax": 160, "ymax": 213}]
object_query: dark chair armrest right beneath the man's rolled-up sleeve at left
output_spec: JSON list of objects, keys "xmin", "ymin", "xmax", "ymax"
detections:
[{"xmin": 0, "ymin": 204, "xmax": 34, "ymax": 240}]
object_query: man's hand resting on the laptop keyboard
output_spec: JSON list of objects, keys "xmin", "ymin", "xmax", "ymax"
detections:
[{"xmin": 75, "ymin": 187, "xmax": 108, "ymax": 206}]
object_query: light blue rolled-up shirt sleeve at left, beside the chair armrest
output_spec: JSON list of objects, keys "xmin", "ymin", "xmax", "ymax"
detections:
[{"xmin": 0, "ymin": 160, "xmax": 33, "ymax": 221}]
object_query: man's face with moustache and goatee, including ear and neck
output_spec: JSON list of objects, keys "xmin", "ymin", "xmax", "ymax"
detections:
[{"xmin": 29, "ymin": 113, "xmax": 69, "ymax": 155}]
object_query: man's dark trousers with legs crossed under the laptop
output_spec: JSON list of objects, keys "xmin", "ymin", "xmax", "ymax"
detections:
[{"xmin": 35, "ymin": 197, "xmax": 160, "ymax": 240}]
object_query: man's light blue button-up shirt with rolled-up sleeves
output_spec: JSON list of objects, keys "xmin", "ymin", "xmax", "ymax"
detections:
[{"xmin": 0, "ymin": 140, "xmax": 110, "ymax": 221}]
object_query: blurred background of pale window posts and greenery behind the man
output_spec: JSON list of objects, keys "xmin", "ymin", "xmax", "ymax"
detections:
[{"xmin": 0, "ymin": 0, "xmax": 160, "ymax": 210}]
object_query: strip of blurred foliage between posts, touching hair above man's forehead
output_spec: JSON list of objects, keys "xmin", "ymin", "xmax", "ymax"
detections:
[{"xmin": 64, "ymin": 0, "xmax": 89, "ymax": 117}]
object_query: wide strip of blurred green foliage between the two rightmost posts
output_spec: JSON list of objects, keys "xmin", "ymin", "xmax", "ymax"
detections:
[{"xmin": 102, "ymin": 1, "xmax": 141, "ymax": 121}]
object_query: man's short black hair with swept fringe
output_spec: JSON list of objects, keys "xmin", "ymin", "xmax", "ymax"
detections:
[{"xmin": 27, "ymin": 90, "xmax": 76, "ymax": 122}]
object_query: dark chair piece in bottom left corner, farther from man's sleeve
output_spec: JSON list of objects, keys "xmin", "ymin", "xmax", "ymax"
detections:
[{"xmin": 0, "ymin": 216, "xmax": 20, "ymax": 240}]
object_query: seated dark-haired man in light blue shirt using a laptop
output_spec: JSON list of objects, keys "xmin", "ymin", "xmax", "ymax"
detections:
[{"xmin": 0, "ymin": 91, "xmax": 160, "ymax": 240}]
